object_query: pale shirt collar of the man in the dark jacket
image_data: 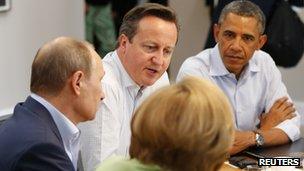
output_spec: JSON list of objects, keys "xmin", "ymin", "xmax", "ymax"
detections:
[{"xmin": 31, "ymin": 93, "xmax": 80, "ymax": 148}]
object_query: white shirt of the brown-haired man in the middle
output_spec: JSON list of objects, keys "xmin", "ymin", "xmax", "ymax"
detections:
[{"xmin": 80, "ymin": 51, "xmax": 169, "ymax": 171}]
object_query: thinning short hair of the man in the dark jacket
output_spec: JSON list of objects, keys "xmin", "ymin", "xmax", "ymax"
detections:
[{"xmin": 30, "ymin": 37, "xmax": 92, "ymax": 95}]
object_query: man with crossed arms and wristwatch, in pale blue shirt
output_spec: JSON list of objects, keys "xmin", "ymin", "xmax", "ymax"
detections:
[{"xmin": 177, "ymin": 0, "xmax": 300, "ymax": 154}]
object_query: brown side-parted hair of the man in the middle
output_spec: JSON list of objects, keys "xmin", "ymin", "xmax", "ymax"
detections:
[{"xmin": 119, "ymin": 3, "xmax": 179, "ymax": 44}]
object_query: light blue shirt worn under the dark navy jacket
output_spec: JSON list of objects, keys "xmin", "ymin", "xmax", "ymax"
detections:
[{"xmin": 31, "ymin": 93, "xmax": 80, "ymax": 170}]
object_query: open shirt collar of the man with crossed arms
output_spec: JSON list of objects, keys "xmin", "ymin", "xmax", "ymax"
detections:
[{"xmin": 209, "ymin": 44, "xmax": 260, "ymax": 76}]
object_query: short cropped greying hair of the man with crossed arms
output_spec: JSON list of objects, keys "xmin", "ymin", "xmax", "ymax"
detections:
[{"xmin": 218, "ymin": 0, "xmax": 266, "ymax": 34}]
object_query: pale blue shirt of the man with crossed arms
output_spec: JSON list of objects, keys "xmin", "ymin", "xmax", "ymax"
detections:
[{"xmin": 177, "ymin": 45, "xmax": 300, "ymax": 141}]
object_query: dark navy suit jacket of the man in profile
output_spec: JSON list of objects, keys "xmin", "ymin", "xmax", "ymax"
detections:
[{"xmin": 0, "ymin": 97, "xmax": 75, "ymax": 171}]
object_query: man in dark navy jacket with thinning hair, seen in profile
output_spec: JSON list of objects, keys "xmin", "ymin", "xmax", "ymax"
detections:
[{"xmin": 0, "ymin": 37, "xmax": 104, "ymax": 171}]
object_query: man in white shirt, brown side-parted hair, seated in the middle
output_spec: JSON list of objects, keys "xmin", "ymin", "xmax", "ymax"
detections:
[{"xmin": 81, "ymin": 3, "xmax": 178, "ymax": 170}]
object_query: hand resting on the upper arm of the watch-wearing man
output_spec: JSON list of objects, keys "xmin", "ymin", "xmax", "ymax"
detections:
[{"xmin": 259, "ymin": 97, "xmax": 296, "ymax": 130}]
